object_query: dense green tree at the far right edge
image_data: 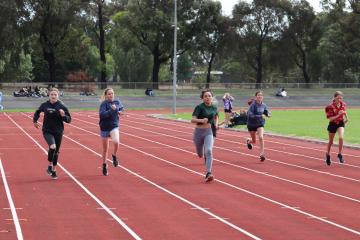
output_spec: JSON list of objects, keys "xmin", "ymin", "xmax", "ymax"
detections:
[{"xmin": 319, "ymin": 0, "xmax": 360, "ymax": 83}]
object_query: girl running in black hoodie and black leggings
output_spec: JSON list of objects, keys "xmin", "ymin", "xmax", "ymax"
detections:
[{"xmin": 33, "ymin": 88, "xmax": 71, "ymax": 179}]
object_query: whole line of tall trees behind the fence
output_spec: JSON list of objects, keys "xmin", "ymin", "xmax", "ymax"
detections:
[{"xmin": 0, "ymin": 0, "xmax": 360, "ymax": 88}]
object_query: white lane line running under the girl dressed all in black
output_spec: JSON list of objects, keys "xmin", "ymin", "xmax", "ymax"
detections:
[{"xmin": 5, "ymin": 114, "xmax": 141, "ymax": 240}]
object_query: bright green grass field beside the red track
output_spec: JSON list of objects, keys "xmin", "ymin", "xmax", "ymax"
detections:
[{"xmin": 168, "ymin": 109, "xmax": 360, "ymax": 144}]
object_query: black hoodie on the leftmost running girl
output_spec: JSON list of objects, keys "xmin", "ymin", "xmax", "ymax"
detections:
[{"xmin": 33, "ymin": 101, "xmax": 71, "ymax": 134}]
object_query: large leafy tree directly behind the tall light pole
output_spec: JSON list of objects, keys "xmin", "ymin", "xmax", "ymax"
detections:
[{"xmin": 121, "ymin": 0, "xmax": 201, "ymax": 89}]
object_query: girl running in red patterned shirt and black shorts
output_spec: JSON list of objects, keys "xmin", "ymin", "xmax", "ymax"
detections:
[{"xmin": 325, "ymin": 91, "xmax": 349, "ymax": 165}]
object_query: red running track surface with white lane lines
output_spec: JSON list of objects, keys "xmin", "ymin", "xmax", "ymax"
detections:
[{"xmin": 0, "ymin": 111, "xmax": 360, "ymax": 240}]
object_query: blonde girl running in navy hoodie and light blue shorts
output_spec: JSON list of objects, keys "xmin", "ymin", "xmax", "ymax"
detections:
[{"xmin": 99, "ymin": 88, "xmax": 124, "ymax": 176}]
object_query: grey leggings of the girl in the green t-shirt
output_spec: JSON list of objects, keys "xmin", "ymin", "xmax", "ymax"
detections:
[{"xmin": 193, "ymin": 128, "xmax": 214, "ymax": 172}]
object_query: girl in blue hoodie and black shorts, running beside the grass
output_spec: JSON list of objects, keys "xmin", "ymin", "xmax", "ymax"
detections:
[{"xmin": 246, "ymin": 91, "xmax": 270, "ymax": 161}]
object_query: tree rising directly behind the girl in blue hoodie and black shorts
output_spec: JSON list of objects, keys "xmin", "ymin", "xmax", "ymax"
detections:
[{"xmin": 233, "ymin": 0, "xmax": 287, "ymax": 88}]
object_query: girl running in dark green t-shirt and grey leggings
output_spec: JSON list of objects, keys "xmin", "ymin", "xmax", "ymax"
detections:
[{"xmin": 191, "ymin": 90, "xmax": 218, "ymax": 182}]
